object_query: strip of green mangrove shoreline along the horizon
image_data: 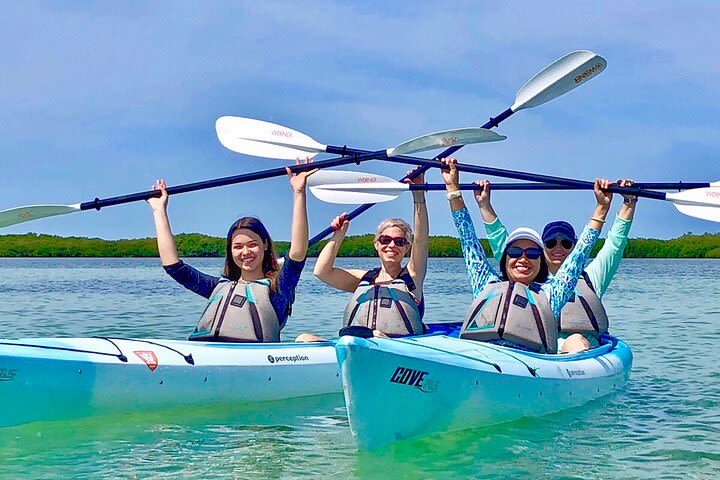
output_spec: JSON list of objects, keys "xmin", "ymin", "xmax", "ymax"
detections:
[{"xmin": 0, "ymin": 233, "xmax": 720, "ymax": 258}]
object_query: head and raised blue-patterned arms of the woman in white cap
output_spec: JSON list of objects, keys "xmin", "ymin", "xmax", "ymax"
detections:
[{"xmin": 441, "ymin": 159, "xmax": 612, "ymax": 352}]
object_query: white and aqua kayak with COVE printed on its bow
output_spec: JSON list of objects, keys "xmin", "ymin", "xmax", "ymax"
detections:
[{"xmin": 335, "ymin": 335, "xmax": 632, "ymax": 449}]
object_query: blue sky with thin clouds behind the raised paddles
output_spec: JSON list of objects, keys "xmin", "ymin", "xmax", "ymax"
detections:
[{"xmin": 0, "ymin": 1, "xmax": 720, "ymax": 240}]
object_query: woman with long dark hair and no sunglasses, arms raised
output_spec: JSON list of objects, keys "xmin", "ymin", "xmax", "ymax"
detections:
[{"xmin": 148, "ymin": 161, "xmax": 314, "ymax": 342}]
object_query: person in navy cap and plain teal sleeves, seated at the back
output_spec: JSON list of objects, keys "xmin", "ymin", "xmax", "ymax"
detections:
[{"xmin": 475, "ymin": 180, "xmax": 637, "ymax": 353}]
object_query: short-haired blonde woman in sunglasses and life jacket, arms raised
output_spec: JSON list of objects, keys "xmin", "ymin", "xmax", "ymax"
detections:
[{"xmin": 297, "ymin": 172, "xmax": 429, "ymax": 341}]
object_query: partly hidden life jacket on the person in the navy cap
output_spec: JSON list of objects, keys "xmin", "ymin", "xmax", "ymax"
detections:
[{"xmin": 560, "ymin": 272, "xmax": 610, "ymax": 335}]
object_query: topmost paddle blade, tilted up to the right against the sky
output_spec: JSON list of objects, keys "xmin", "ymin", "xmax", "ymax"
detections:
[{"xmin": 510, "ymin": 50, "xmax": 607, "ymax": 112}]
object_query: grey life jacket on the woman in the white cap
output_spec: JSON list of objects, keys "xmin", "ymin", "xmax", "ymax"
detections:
[{"xmin": 460, "ymin": 281, "xmax": 558, "ymax": 353}]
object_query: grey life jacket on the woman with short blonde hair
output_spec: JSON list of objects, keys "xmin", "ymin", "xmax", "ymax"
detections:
[{"xmin": 344, "ymin": 268, "xmax": 425, "ymax": 337}]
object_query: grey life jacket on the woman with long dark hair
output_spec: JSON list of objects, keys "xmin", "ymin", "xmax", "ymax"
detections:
[{"xmin": 189, "ymin": 279, "xmax": 280, "ymax": 342}]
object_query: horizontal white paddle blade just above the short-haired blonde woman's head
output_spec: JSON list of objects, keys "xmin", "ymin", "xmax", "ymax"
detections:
[{"xmin": 308, "ymin": 170, "xmax": 408, "ymax": 204}]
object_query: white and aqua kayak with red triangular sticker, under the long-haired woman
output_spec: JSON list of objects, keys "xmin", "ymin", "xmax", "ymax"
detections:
[{"xmin": 0, "ymin": 338, "xmax": 342, "ymax": 426}]
